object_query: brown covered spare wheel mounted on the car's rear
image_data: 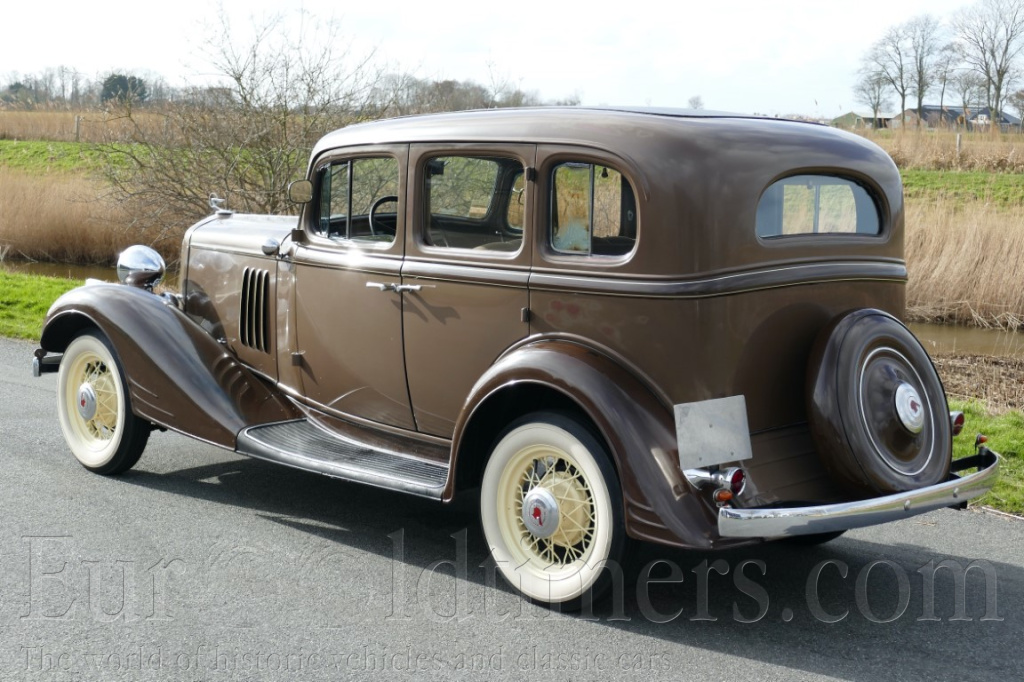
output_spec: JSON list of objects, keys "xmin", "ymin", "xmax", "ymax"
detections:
[{"xmin": 807, "ymin": 309, "xmax": 952, "ymax": 495}]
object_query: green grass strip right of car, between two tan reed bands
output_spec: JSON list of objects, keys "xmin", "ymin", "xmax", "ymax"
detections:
[{"xmin": 900, "ymin": 170, "xmax": 1024, "ymax": 208}]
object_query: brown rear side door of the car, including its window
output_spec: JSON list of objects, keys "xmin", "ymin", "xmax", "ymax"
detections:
[{"xmin": 401, "ymin": 144, "xmax": 536, "ymax": 437}]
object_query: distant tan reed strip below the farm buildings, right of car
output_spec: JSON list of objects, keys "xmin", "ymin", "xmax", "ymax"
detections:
[{"xmin": 862, "ymin": 130, "xmax": 1024, "ymax": 173}]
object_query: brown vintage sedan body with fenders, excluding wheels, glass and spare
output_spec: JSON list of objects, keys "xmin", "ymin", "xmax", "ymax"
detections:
[{"xmin": 41, "ymin": 109, "xmax": 994, "ymax": 602}]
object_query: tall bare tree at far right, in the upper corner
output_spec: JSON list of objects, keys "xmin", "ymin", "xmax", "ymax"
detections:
[{"xmin": 952, "ymin": 0, "xmax": 1024, "ymax": 122}]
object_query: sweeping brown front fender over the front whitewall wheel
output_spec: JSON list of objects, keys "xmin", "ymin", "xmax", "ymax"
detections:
[{"xmin": 40, "ymin": 285, "xmax": 299, "ymax": 450}]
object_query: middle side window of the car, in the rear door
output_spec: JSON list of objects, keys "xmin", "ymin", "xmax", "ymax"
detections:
[{"xmin": 423, "ymin": 156, "xmax": 524, "ymax": 251}]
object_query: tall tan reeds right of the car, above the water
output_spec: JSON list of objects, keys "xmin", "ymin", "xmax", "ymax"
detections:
[{"xmin": 905, "ymin": 196, "xmax": 1024, "ymax": 330}]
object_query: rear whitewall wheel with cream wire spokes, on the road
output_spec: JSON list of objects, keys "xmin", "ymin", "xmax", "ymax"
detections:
[{"xmin": 480, "ymin": 413, "xmax": 626, "ymax": 610}]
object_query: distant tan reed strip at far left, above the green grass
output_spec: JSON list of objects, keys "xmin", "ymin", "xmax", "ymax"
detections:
[{"xmin": 0, "ymin": 111, "xmax": 164, "ymax": 143}]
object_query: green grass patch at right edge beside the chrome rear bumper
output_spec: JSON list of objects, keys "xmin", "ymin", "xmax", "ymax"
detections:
[{"xmin": 950, "ymin": 400, "xmax": 1024, "ymax": 516}]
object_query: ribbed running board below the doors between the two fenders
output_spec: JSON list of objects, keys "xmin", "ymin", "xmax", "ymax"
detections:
[{"xmin": 236, "ymin": 419, "xmax": 449, "ymax": 500}]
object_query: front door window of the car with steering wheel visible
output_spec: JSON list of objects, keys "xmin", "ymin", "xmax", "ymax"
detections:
[{"xmin": 316, "ymin": 157, "xmax": 398, "ymax": 243}]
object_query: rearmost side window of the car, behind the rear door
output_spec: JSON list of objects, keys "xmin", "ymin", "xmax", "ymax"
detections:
[{"xmin": 550, "ymin": 162, "xmax": 637, "ymax": 256}]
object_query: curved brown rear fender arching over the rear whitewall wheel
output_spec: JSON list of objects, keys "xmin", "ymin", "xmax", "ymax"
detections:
[{"xmin": 445, "ymin": 339, "xmax": 718, "ymax": 549}]
